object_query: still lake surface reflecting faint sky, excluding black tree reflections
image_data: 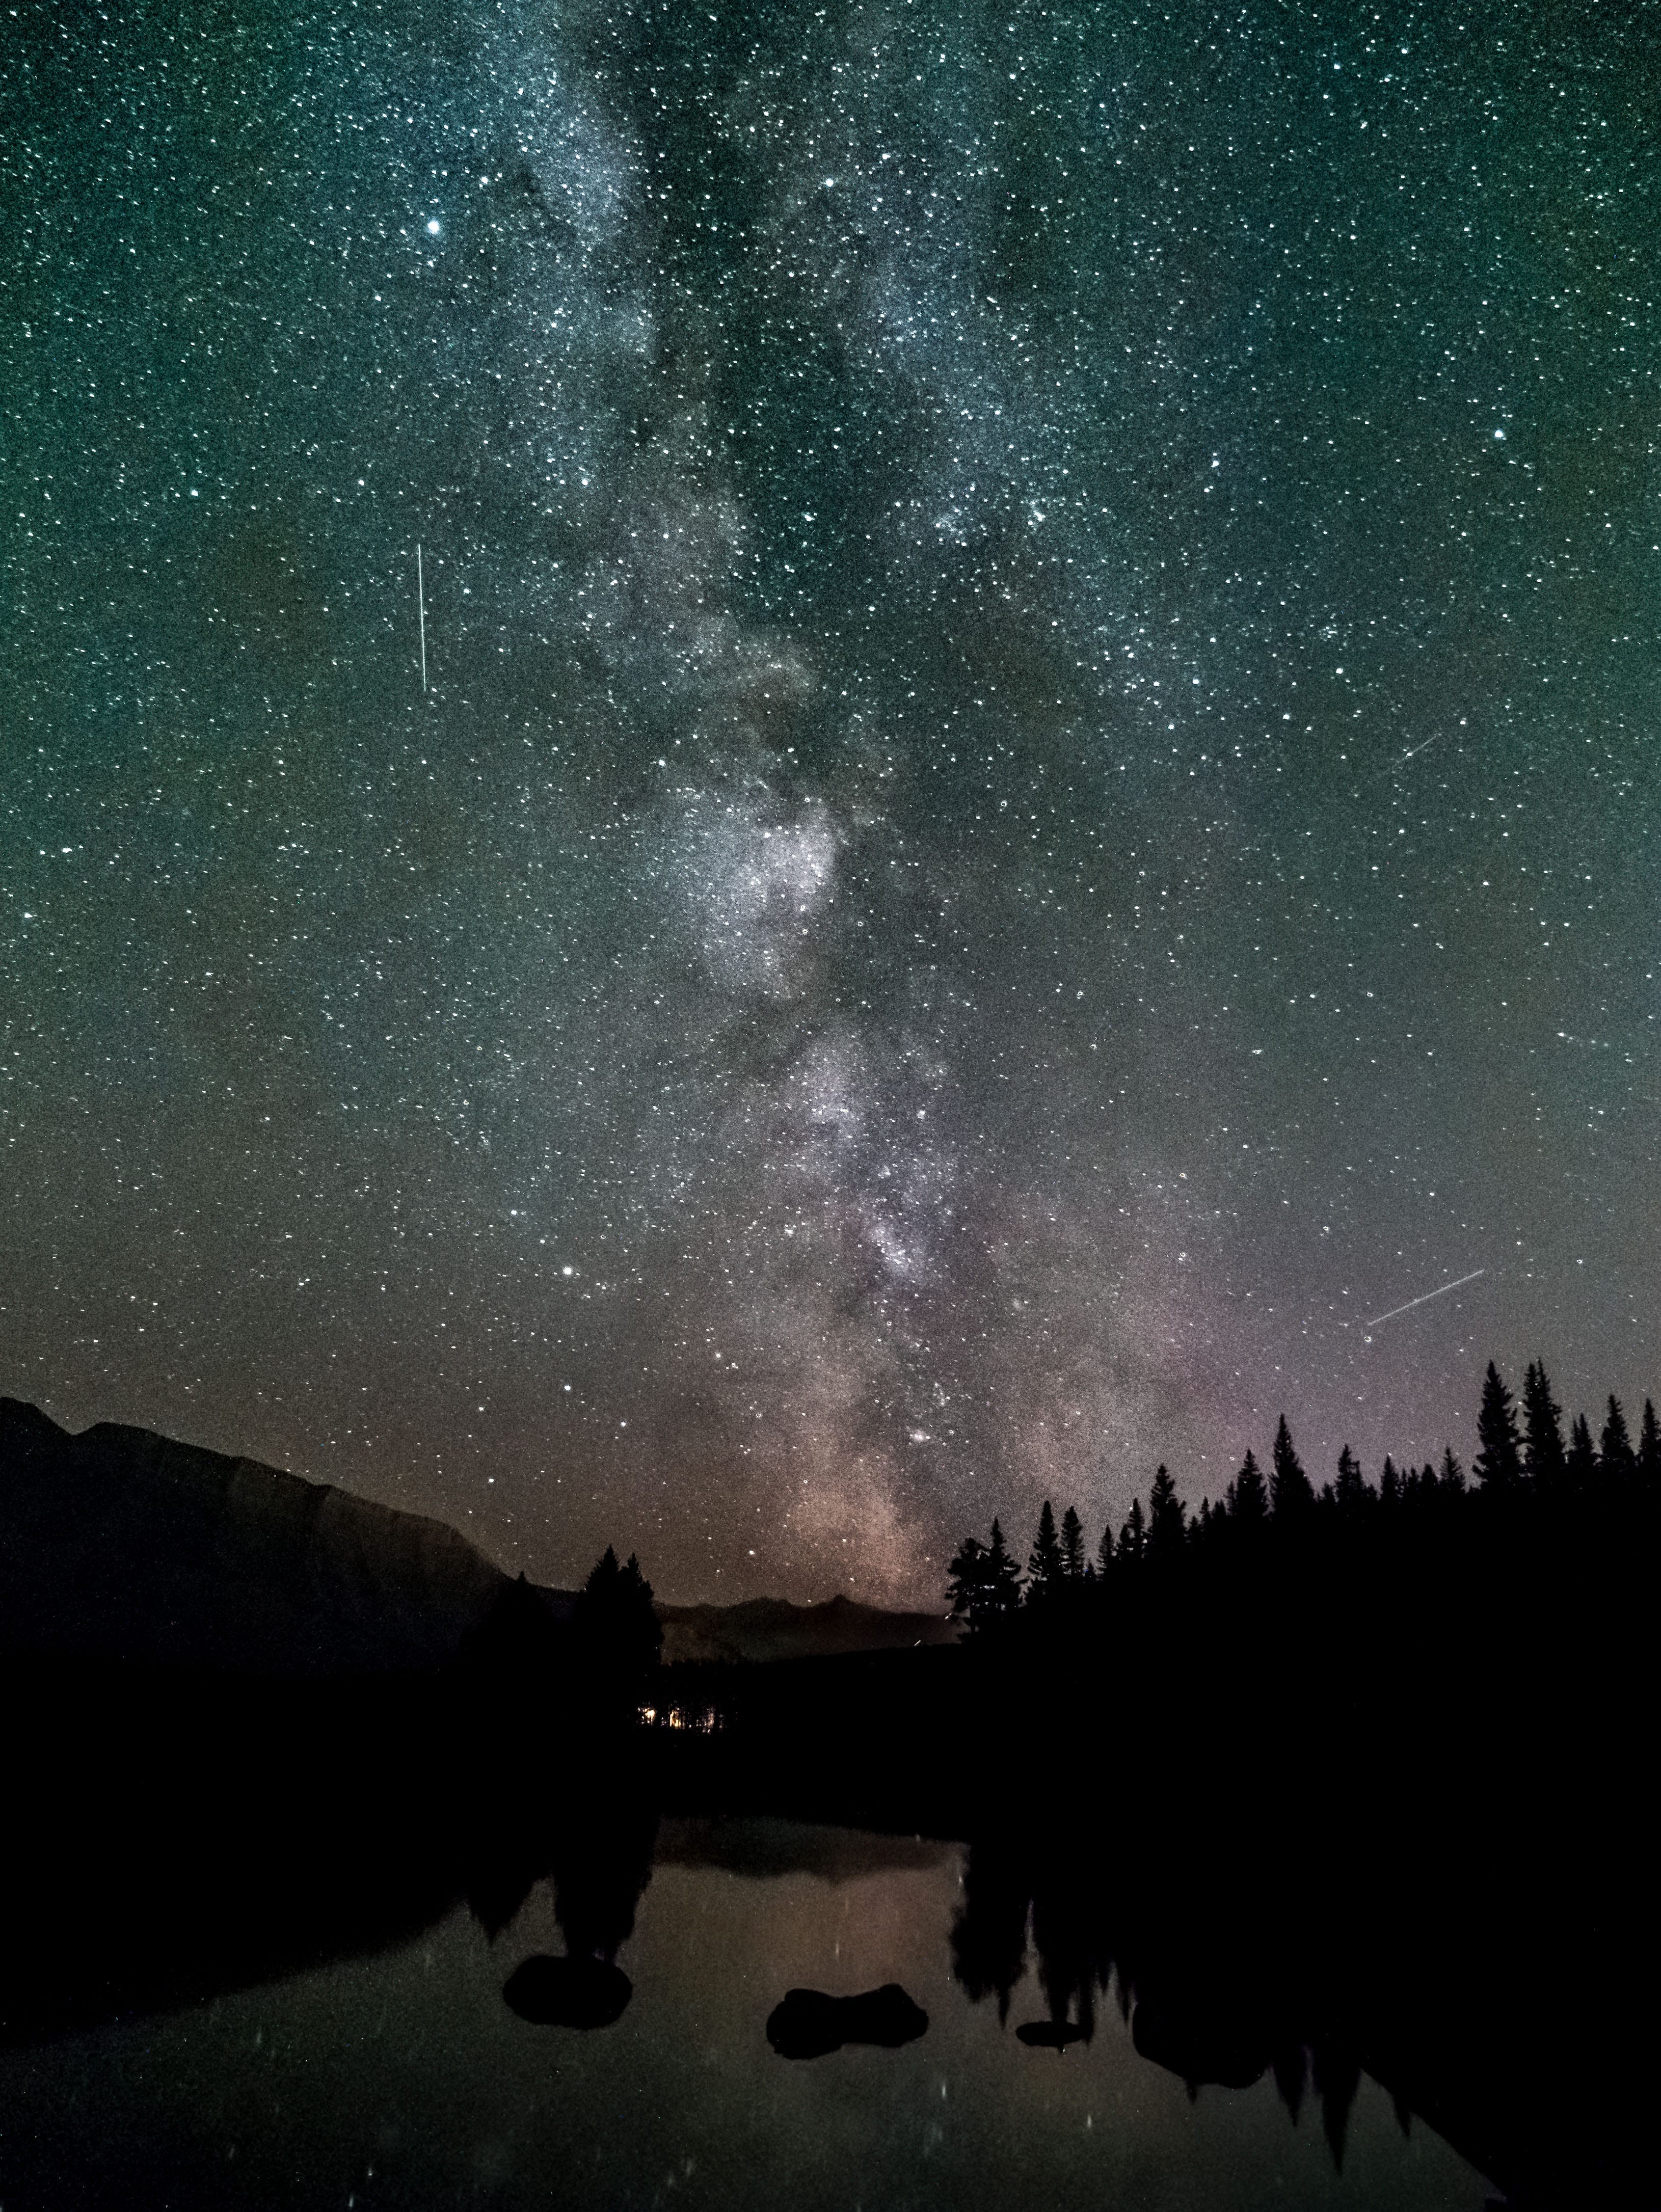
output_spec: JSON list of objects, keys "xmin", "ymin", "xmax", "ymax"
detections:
[{"xmin": 0, "ymin": 1823, "xmax": 1491, "ymax": 2212}]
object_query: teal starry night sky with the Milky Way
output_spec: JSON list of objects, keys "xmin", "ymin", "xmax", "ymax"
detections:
[{"xmin": 0, "ymin": 0, "xmax": 1661, "ymax": 1602}]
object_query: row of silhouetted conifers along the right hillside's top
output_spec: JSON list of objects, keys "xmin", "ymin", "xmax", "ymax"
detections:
[{"xmin": 947, "ymin": 1360, "xmax": 1661, "ymax": 1637}]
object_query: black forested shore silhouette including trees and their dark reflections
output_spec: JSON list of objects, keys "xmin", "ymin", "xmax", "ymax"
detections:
[{"xmin": 0, "ymin": 1360, "xmax": 1661, "ymax": 2205}]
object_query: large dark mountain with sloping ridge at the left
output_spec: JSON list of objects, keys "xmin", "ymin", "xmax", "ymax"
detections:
[{"xmin": 0, "ymin": 1398, "xmax": 511, "ymax": 1677}]
